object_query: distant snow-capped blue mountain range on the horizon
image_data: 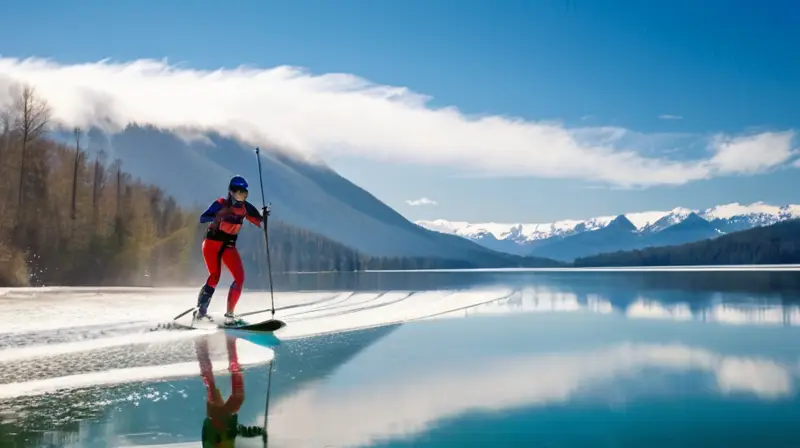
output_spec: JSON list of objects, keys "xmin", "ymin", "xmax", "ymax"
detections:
[{"xmin": 416, "ymin": 202, "xmax": 800, "ymax": 262}]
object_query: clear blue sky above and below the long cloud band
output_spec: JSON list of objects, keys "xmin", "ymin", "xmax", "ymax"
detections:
[{"xmin": 0, "ymin": 0, "xmax": 800, "ymax": 222}]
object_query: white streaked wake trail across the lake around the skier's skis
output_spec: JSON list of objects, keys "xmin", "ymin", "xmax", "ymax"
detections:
[{"xmin": 0, "ymin": 287, "xmax": 513, "ymax": 400}]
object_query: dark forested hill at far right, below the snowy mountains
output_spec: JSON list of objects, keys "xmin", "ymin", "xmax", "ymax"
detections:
[{"xmin": 573, "ymin": 219, "xmax": 800, "ymax": 267}]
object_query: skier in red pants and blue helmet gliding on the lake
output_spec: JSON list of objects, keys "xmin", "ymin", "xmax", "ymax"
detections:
[{"xmin": 195, "ymin": 176, "xmax": 269, "ymax": 325}]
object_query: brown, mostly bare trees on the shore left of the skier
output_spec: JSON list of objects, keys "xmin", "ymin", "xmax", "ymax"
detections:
[{"xmin": 0, "ymin": 86, "xmax": 194, "ymax": 285}]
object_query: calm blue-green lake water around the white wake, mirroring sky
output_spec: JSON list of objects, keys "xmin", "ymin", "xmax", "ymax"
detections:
[{"xmin": 0, "ymin": 272, "xmax": 800, "ymax": 447}]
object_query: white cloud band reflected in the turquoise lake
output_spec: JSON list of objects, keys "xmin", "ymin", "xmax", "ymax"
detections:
[{"xmin": 260, "ymin": 343, "xmax": 796, "ymax": 446}]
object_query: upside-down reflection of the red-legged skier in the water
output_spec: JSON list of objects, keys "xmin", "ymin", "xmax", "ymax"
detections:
[{"xmin": 195, "ymin": 334, "xmax": 266, "ymax": 448}]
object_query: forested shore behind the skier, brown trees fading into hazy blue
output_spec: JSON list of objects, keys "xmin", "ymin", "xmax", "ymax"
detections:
[{"xmin": 0, "ymin": 84, "xmax": 560, "ymax": 286}]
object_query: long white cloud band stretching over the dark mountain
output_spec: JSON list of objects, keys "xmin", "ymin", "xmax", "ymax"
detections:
[{"xmin": 0, "ymin": 58, "xmax": 794, "ymax": 187}]
